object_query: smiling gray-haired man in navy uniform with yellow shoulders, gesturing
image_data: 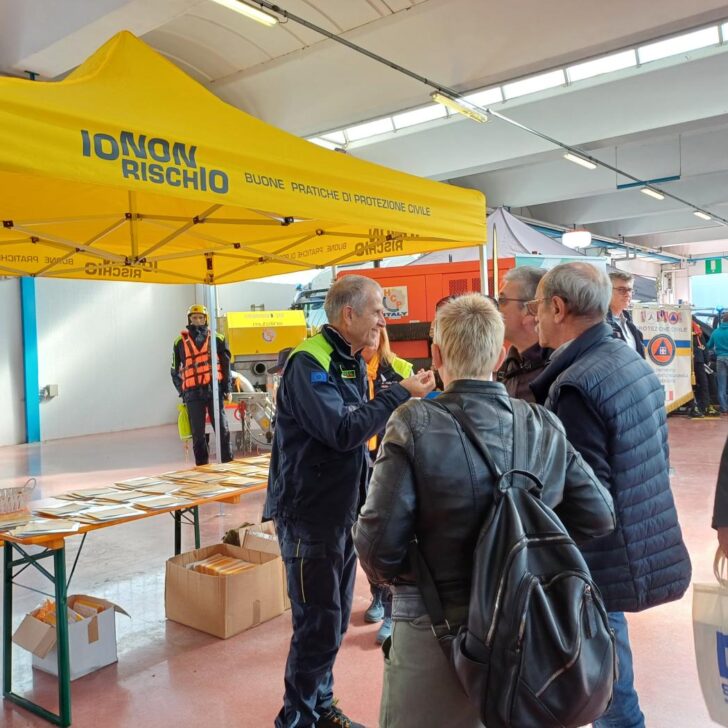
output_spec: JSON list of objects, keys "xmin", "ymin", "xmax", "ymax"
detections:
[{"xmin": 264, "ymin": 275, "xmax": 434, "ymax": 728}]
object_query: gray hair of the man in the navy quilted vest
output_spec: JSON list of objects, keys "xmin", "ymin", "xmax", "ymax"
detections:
[{"xmin": 541, "ymin": 262, "xmax": 612, "ymax": 319}]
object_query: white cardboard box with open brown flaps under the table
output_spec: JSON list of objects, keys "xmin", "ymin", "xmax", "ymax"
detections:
[{"xmin": 13, "ymin": 594, "xmax": 129, "ymax": 680}]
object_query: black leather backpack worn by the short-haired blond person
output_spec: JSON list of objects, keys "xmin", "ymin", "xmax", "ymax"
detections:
[{"xmin": 410, "ymin": 400, "xmax": 616, "ymax": 728}]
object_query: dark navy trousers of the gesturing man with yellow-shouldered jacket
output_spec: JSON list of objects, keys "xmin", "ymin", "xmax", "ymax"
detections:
[{"xmin": 275, "ymin": 518, "xmax": 356, "ymax": 728}]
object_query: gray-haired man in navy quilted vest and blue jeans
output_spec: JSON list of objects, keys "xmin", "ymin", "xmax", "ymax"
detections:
[{"xmin": 529, "ymin": 263, "xmax": 691, "ymax": 728}]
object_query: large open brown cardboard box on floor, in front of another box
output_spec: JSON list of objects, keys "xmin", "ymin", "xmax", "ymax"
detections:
[{"xmin": 164, "ymin": 543, "xmax": 285, "ymax": 639}]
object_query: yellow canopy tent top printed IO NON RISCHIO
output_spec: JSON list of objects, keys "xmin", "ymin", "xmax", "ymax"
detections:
[{"xmin": 0, "ymin": 32, "xmax": 486, "ymax": 284}]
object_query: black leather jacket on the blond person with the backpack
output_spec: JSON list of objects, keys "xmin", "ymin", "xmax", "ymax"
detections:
[{"xmin": 353, "ymin": 380, "xmax": 615, "ymax": 618}]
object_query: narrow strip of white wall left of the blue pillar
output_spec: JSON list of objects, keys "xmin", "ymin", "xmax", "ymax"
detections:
[{"xmin": 0, "ymin": 278, "xmax": 25, "ymax": 446}]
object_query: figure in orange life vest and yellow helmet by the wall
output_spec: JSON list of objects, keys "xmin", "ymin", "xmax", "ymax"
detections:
[{"xmin": 171, "ymin": 304, "xmax": 233, "ymax": 465}]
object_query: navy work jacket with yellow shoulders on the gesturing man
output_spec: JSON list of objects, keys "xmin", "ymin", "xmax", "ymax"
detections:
[{"xmin": 263, "ymin": 325, "xmax": 409, "ymax": 533}]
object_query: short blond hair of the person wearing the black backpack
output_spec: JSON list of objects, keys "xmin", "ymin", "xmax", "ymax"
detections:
[{"xmin": 433, "ymin": 293, "xmax": 505, "ymax": 379}]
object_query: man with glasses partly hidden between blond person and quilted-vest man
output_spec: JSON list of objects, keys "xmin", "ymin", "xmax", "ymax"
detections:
[{"xmin": 498, "ymin": 265, "xmax": 550, "ymax": 402}]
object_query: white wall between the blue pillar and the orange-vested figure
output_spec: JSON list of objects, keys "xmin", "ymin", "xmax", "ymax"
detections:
[{"xmin": 36, "ymin": 279, "xmax": 194, "ymax": 440}]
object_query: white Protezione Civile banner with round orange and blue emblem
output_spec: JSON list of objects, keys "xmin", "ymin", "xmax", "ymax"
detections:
[{"xmin": 632, "ymin": 303, "xmax": 693, "ymax": 412}]
